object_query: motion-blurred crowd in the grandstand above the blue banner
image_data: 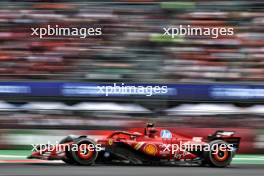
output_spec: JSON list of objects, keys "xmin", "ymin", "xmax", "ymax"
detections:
[{"xmin": 0, "ymin": 0, "xmax": 264, "ymax": 82}]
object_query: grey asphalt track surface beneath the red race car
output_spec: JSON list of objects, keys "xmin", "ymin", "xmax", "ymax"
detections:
[{"xmin": 0, "ymin": 163, "xmax": 264, "ymax": 176}]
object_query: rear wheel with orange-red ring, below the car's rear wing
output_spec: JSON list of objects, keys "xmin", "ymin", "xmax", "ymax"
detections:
[{"xmin": 202, "ymin": 140, "xmax": 234, "ymax": 167}]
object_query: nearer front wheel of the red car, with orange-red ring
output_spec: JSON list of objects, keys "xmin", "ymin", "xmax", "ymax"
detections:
[{"xmin": 71, "ymin": 138, "xmax": 98, "ymax": 166}]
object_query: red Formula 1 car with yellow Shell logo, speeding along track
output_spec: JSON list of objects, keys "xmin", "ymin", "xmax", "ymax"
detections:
[{"xmin": 28, "ymin": 124, "xmax": 240, "ymax": 167}]
